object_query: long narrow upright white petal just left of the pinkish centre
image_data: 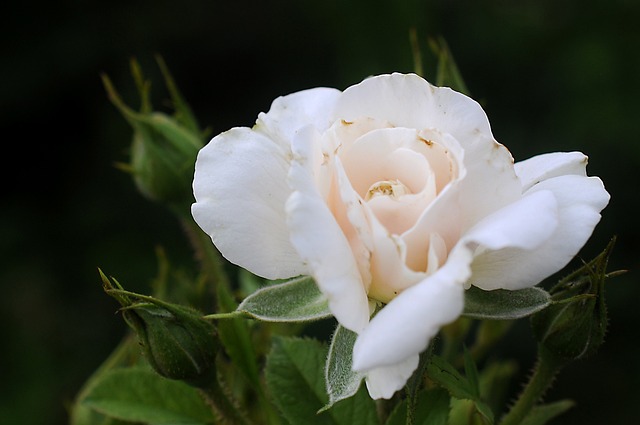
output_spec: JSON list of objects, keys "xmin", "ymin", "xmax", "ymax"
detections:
[{"xmin": 286, "ymin": 126, "xmax": 369, "ymax": 333}]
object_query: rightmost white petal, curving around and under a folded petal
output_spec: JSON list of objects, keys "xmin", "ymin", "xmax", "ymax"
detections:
[{"xmin": 472, "ymin": 175, "xmax": 609, "ymax": 289}]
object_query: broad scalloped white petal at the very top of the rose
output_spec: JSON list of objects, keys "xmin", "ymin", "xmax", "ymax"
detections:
[{"xmin": 334, "ymin": 73, "xmax": 491, "ymax": 140}]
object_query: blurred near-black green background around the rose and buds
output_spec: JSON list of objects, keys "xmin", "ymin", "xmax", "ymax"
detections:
[{"xmin": 0, "ymin": 0, "xmax": 640, "ymax": 424}]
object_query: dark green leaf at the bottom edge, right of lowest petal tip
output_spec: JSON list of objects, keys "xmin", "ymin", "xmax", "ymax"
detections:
[{"xmin": 385, "ymin": 388, "xmax": 450, "ymax": 425}]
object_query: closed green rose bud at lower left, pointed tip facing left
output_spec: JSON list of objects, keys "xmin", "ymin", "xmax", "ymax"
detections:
[{"xmin": 102, "ymin": 275, "xmax": 220, "ymax": 387}]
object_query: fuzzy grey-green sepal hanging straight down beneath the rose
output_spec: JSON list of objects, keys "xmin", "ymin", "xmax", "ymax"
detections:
[{"xmin": 322, "ymin": 325, "xmax": 364, "ymax": 410}]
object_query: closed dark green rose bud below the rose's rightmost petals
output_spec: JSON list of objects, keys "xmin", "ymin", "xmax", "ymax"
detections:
[{"xmin": 531, "ymin": 240, "xmax": 612, "ymax": 360}]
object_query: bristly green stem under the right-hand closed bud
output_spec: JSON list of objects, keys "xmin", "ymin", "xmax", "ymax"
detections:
[{"xmin": 500, "ymin": 346, "xmax": 567, "ymax": 425}]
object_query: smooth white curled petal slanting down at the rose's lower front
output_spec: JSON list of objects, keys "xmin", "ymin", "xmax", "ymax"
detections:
[{"xmin": 353, "ymin": 268, "xmax": 462, "ymax": 371}]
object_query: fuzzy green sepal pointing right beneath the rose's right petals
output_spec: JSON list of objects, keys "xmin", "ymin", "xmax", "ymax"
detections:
[{"xmin": 463, "ymin": 286, "xmax": 551, "ymax": 320}]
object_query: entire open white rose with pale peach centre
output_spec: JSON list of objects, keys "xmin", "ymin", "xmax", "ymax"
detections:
[{"xmin": 192, "ymin": 74, "xmax": 609, "ymax": 398}]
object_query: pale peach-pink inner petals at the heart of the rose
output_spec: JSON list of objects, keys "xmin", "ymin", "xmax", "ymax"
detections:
[{"xmin": 324, "ymin": 123, "xmax": 458, "ymax": 302}]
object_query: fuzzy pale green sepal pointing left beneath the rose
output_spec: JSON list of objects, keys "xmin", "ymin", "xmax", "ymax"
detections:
[{"xmin": 238, "ymin": 276, "xmax": 331, "ymax": 322}]
